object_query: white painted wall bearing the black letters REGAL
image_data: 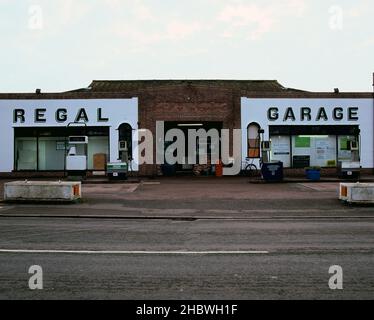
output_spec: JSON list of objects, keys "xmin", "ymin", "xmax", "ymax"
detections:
[{"xmin": 0, "ymin": 98, "xmax": 138, "ymax": 172}]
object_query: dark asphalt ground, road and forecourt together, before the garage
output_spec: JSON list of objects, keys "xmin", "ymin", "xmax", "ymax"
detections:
[{"xmin": 0, "ymin": 179, "xmax": 374, "ymax": 300}]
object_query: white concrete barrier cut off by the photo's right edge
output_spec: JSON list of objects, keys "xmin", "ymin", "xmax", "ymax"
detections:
[{"xmin": 339, "ymin": 183, "xmax": 374, "ymax": 204}]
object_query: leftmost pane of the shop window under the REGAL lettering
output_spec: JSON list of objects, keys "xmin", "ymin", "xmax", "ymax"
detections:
[{"xmin": 15, "ymin": 137, "xmax": 38, "ymax": 170}]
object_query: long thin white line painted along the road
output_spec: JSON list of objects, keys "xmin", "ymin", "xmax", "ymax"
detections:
[{"xmin": 0, "ymin": 249, "xmax": 269, "ymax": 255}]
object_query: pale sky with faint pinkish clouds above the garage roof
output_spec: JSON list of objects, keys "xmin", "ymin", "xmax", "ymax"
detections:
[{"xmin": 0, "ymin": 0, "xmax": 374, "ymax": 92}]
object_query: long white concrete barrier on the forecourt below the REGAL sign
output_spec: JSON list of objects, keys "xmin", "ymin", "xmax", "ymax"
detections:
[{"xmin": 4, "ymin": 180, "xmax": 82, "ymax": 202}]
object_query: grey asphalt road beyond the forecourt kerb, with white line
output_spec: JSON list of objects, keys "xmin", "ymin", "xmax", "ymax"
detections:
[{"xmin": 0, "ymin": 208, "xmax": 374, "ymax": 299}]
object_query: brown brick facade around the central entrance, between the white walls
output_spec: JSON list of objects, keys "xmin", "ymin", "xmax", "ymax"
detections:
[{"xmin": 139, "ymin": 85, "xmax": 240, "ymax": 175}]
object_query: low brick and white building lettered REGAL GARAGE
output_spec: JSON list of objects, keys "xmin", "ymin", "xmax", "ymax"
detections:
[{"xmin": 0, "ymin": 80, "xmax": 374, "ymax": 176}]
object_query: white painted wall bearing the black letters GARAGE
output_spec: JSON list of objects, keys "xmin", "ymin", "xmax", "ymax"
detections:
[{"xmin": 241, "ymin": 98, "xmax": 374, "ymax": 168}]
